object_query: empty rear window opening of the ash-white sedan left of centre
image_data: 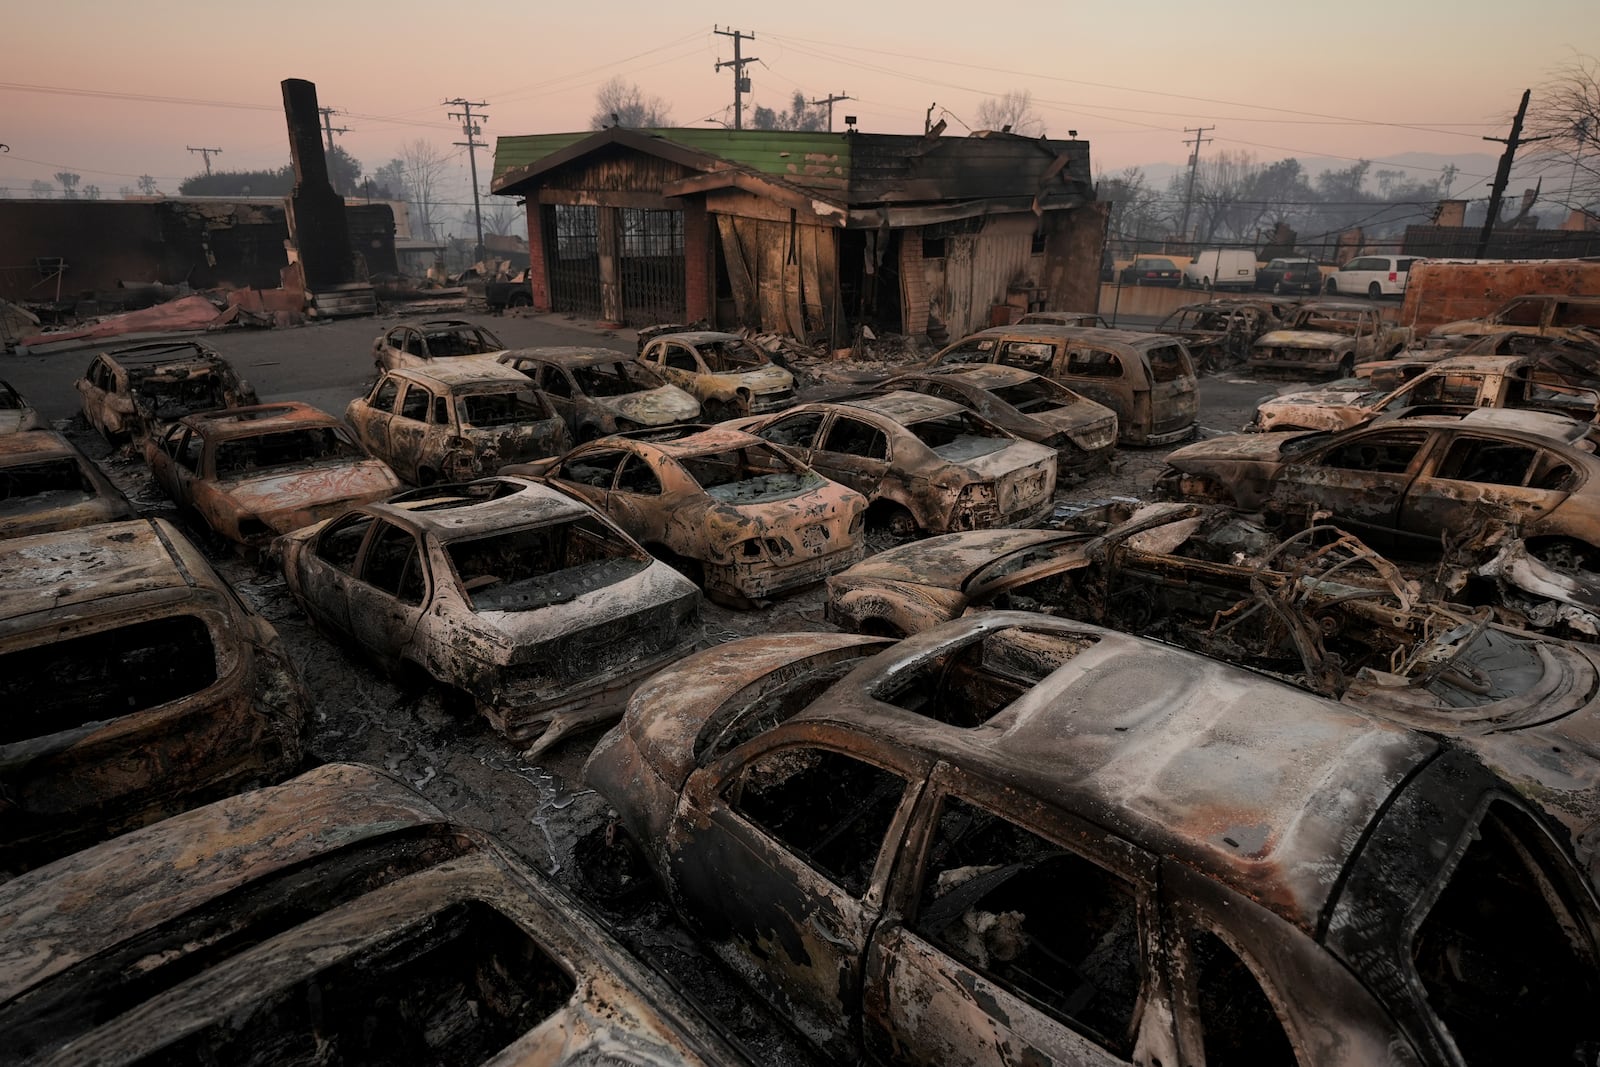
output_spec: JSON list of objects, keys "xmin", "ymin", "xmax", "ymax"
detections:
[{"xmin": 445, "ymin": 517, "xmax": 650, "ymax": 611}]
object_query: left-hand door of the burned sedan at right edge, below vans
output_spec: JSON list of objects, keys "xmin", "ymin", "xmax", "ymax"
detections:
[{"xmin": 1270, "ymin": 427, "xmax": 1430, "ymax": 544}]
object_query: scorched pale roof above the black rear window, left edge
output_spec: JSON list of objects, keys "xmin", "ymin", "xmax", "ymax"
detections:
[{"xmin": 0, "ymin": 518, "xmax": 214, "ymax": 621}]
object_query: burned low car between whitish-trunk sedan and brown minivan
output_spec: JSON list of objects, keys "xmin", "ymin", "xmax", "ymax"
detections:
[{"xmin": 882, "ymin": 363, "xmax": 1117, "ymax": 472}]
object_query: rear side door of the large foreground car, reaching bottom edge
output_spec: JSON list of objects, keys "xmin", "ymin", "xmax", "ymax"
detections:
[{"xmin": 862, "ymin": 765, "xmax": 1178, "ymax": 1067}]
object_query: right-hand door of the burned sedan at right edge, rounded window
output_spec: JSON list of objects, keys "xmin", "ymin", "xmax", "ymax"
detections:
[{"xmin": 1400, "ymin": 432, "xmax": 1574, "ymax": 545}]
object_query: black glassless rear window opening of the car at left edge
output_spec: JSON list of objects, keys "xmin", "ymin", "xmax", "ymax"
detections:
[{"xmin": 0, "ymin": 614, "xmax": 218, "ymax": 744}]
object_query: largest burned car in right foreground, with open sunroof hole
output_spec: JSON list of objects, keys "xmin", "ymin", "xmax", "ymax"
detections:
[{"xmin": 586, "ymin": 613, "xmax": 1600, "ymax": 1067}]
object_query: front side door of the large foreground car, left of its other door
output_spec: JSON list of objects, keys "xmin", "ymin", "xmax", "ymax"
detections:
[{"xmin": 667, "ymin": 731, "xmax": 922, "ymax": 1057}]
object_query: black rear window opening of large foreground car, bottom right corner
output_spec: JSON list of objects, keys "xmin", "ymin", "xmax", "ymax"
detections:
[{"xmin": 1411, "ymin": 801, "xmax": 1600, "ymax": 1067}]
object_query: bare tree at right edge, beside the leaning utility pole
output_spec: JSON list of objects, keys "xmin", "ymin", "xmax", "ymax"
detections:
[{"xmin": 1523, "ymin": 56, "xmax": 1600, "ymax": 210}]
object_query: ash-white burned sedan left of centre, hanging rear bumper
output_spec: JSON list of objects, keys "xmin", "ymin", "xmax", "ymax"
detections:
[{"xmin": 277, "ymin": 478, "xmax": 699, "ymax": 753}]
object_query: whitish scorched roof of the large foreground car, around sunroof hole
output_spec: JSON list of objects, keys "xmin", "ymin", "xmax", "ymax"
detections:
[{"xmin": 790, "ymin": 611, "xmax": 1440, "ymax": 931}]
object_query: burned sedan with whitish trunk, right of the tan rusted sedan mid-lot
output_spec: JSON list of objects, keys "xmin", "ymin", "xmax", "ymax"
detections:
[{"xmin": 738, "ymin": 390, "xmax": 1056, "ymax": 537}]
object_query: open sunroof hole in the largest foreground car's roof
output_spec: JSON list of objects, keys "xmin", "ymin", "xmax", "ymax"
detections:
[{"xmin": 870, "ymin": 627, "xmax": 1099, "ymax": 728}]
